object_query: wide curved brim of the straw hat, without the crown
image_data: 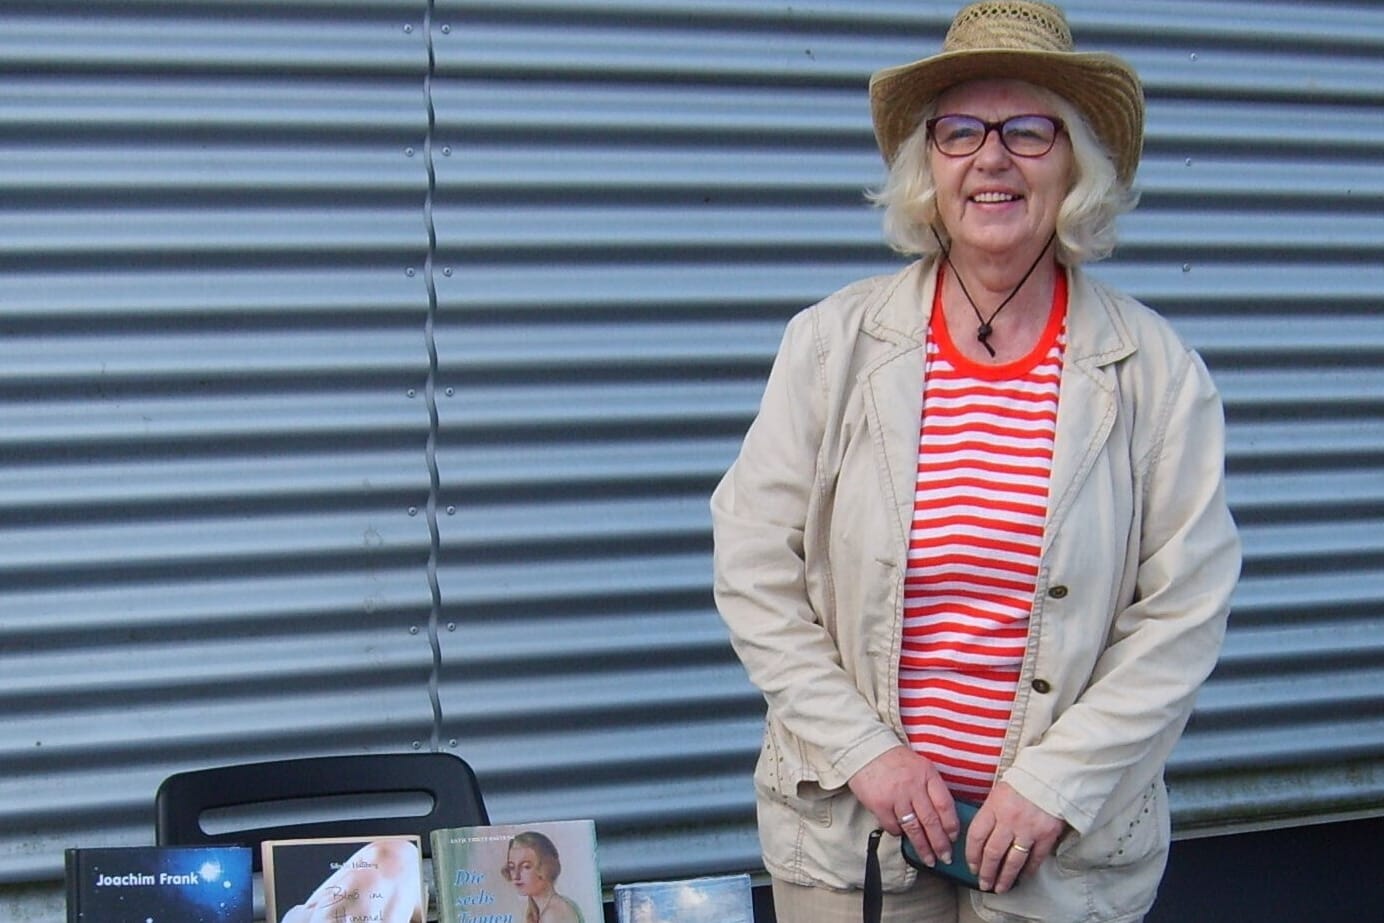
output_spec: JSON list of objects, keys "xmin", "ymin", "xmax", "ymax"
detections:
[{"xmin": 869, "ymin": 50, "xmax": 1143, "ymax": 184}]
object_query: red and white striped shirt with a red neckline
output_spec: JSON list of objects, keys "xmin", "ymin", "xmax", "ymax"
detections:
[{"xmin": 898, "ymin": 273, "xmax": 1067, "ymax": 801}]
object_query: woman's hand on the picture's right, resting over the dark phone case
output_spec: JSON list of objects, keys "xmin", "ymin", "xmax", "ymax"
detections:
[{"xmin": 966, "ymin": 782, "xmax": 1067, "ymax": 894}]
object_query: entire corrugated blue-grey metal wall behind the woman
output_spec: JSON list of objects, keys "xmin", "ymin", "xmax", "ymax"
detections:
[{"xmin": 0, "ymin": 0, "xmax": 1384, "ymax": 919}]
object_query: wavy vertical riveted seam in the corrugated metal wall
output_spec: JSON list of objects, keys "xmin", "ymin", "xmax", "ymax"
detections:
[{"xmin": 424, "ymin": 0, "xmax": 441, "ymax": 750}]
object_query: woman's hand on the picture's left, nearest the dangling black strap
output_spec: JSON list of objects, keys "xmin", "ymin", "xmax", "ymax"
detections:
[{"xmin": 847, "ymin": 746, "xmax": 960, "ymax": 865}]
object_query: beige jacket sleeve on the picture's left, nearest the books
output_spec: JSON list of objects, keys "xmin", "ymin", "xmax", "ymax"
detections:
[{"xmin": 711, "ymin": 309, "xmax": 900, "ymax": 789}]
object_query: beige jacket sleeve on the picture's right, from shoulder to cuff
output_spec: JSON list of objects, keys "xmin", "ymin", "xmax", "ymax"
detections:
[{"xmin": 1003, "ymin": 351, "xmax": 1240, "ymax": 833}]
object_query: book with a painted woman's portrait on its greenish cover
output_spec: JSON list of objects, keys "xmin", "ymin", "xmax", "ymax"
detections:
[{"xmin": 432, "ymin": 821, "xmax": 605, "ymax": 923}]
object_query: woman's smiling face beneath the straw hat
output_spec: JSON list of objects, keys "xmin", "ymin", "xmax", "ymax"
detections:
[{"xmin": 927, "ymin": 80, "xmax": 1073, "ymax": 262}]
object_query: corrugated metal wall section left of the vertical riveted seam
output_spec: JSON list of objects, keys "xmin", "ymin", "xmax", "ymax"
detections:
[{"xmin": 0, "ymin": 1, "xmax": 436, "ymax": 920}]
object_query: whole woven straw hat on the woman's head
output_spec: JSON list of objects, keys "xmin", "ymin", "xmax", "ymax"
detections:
[{"xmin": 869, "ymin": 0, "xmax": 1143, "ymax": 184}]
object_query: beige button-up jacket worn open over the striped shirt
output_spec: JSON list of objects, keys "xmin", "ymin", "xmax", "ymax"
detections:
[{"xmin": 711, "ymin": 262, "xmax": 1240, "ymax": 923}]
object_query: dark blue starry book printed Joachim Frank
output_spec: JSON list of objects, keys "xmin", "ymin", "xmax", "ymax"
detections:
[{"xmin": 64, "ymin": 846, "xmax": 255, "ymax": 923}]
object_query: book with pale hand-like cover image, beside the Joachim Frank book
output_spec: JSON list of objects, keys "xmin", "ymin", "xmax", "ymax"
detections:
[{"xmin": 260, "ymin": 836, "xmax": 428, "ymax": 923}]
